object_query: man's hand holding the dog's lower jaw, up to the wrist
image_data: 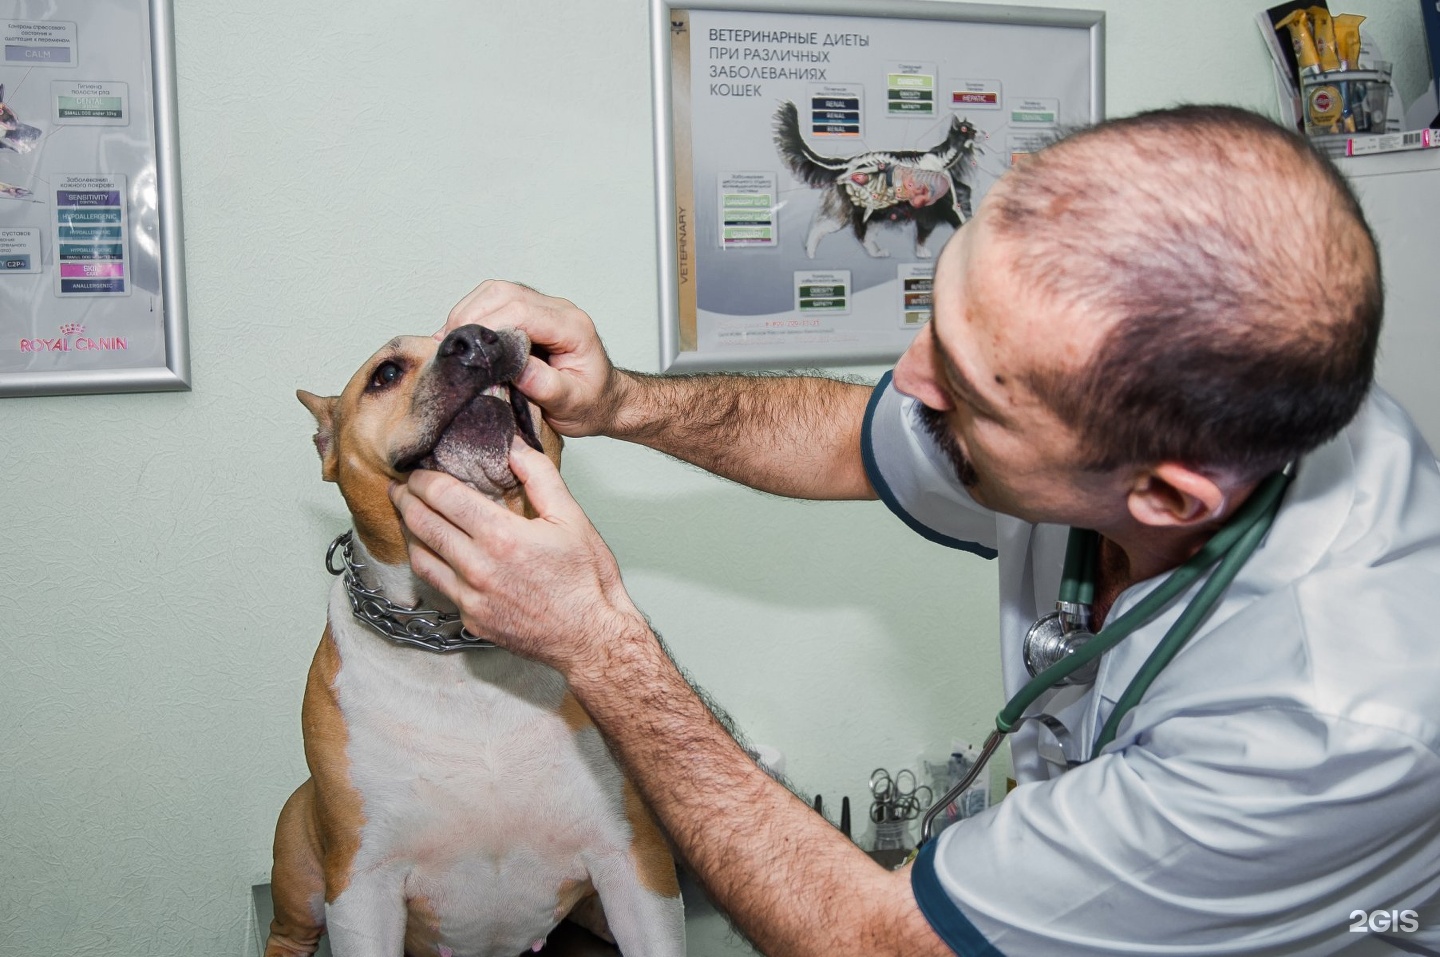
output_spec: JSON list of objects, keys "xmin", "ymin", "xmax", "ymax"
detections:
[{"xmin": 390, "ymin": 440, "xmax": 644, "ymax": 678}]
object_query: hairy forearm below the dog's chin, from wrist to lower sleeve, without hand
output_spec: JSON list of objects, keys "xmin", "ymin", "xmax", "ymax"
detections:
[{"xmin": 570, "ymin": 619, "xmax": 949, "ymax": 957}]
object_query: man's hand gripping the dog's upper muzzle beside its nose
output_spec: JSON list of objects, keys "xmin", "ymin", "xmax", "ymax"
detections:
[{"xmin": 435, "ymin": 279, "xmax": 629, "ymax": 436}]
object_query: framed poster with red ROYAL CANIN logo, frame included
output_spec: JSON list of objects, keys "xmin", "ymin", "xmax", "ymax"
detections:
[{"xmin": 0, "ymin": 0, "xmax": 190, "ymax": 396}]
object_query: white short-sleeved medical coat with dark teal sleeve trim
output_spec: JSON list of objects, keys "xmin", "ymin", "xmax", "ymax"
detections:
[{"xmin": 864, "ymin": 376, "xmax": 1440, "ymax": 957}]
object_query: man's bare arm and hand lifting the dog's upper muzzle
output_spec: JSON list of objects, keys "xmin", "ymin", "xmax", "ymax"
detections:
[{"xmin": 444, "ymin": 281, "xmax": 876, "ymax": 499}]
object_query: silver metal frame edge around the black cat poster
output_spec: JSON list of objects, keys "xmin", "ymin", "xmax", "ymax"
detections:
[{"xmin": 651, "ymin": 0, "xmax": 1104, "ymax": 373}]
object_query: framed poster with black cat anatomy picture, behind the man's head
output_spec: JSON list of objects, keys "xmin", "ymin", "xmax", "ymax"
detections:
[{"xmin": 651, "ymin": 0, "xmax": 1104, "ymax": 371}]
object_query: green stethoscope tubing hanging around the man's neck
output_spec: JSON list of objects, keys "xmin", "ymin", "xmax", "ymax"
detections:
[{"xmin": 920, "ymin": 468, "xmax": 1293, "ymax": 843}]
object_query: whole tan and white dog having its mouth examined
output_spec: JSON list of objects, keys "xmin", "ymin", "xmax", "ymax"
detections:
[{"xmin": 265, "ymin": 325, "xmax": 684, "ymax": 957}]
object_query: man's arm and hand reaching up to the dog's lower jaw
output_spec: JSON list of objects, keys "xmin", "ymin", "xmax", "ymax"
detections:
[{"xmin": 392, "ymin": 454, "xmax": 950, "ymax": 957}]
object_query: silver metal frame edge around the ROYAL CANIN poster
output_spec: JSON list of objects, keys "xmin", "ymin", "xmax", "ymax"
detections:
[{"xmin": 0, "ymin": 0, "xmax": 190, "ymax": 397}]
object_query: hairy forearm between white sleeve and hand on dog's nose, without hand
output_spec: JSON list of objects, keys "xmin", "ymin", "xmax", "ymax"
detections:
[{"xmin": 606, "ymin": 371, "xmax": 876, "ymax": 499}]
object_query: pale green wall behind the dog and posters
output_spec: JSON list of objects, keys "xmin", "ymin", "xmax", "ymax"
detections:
[{"xmin": 0, "ymin": 0, "xmax": 1423, "ymax": 957}]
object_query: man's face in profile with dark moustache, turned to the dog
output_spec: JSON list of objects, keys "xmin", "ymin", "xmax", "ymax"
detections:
[{"xmin": 894, "ymin": 207, "xmax": 1123, "ymax": 527}]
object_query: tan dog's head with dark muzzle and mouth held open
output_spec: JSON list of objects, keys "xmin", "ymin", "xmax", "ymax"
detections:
[{"xmin": 295, "ymin": 325, "xmax": 560, "ymax": 564}]
